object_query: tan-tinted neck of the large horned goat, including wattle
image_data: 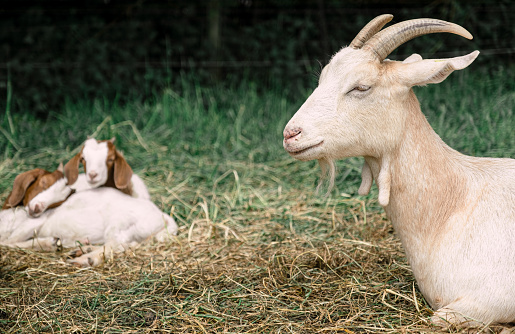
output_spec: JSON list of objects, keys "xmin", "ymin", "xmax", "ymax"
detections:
[{"xmin": 365, "ymin": 96, "xmax": 466, "ymax": 265}]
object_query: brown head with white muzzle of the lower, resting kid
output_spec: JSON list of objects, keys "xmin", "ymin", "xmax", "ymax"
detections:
[{"xmin": 2, "ymin": 163, "xmax": 72, "ymax": 217}]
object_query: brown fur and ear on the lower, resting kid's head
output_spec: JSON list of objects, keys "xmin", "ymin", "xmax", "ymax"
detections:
[{"xmin": 2, "ymin": 163, "xmax": 64, "ymax": 210}]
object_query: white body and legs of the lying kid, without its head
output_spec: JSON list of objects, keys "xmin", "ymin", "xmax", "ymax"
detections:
[{"xmin": 0, "ymin": 187, "xmax": 177, "ymax": 267}]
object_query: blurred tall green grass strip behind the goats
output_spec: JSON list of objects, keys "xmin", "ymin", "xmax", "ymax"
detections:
[{"xmin": 0, "ymin": 64, "xmax": 515, "ymax": 201}]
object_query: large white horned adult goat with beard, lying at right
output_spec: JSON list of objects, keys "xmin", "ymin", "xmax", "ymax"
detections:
[{"xmin": 283, "ymin": 15, "xmax": 515, "ymax": 327}]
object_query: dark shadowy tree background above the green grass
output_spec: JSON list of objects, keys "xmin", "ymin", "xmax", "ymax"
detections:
[{"xmin": 0, "ymin": 0, "xmax": 515, "ymax": 117}]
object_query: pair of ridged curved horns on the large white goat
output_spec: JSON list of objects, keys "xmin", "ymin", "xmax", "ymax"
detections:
[{"xmin": 350, "ymin": 14, "xmax": 472, "ymax": 61}]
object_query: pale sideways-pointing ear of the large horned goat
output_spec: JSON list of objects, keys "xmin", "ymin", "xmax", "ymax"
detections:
[{"xmin": 398, "ymin": 51, "xmax": 479, "ymax": 87}]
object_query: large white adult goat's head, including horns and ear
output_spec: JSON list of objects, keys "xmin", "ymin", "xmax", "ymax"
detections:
[{"xmin": 283, "ymin": 15, "xmax": 479, "ymax": 162}]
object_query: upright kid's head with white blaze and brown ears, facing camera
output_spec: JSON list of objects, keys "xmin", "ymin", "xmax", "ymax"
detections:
[{"xmin": 64, "ymin": 138, "xmax": 132, "ymax": 189}]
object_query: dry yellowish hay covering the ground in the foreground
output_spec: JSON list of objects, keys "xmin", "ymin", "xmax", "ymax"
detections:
[{"xmin": 0, "ymin": 155, "xmax": 512, "ymax": 333}]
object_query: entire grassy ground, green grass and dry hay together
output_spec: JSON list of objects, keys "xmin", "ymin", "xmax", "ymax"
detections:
[{"xmin": 0, "ymin": 66, "xmax": 515, "ymax": 333}]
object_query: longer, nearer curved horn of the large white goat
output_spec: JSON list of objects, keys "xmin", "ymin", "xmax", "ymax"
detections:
[{"xmin": 363, "ymin": 19, "xmax": 472, "ymax": 61}]
